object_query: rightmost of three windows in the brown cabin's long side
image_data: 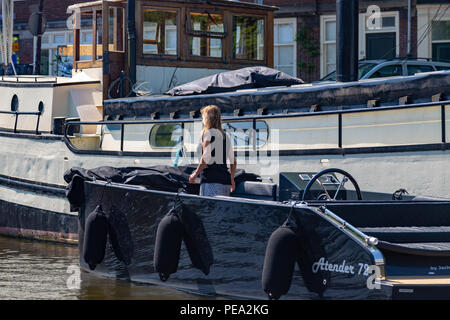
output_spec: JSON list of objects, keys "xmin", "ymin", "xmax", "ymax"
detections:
[{"xmin": 233, "ymin": 15, "xmax": 264, "ymax": 60}]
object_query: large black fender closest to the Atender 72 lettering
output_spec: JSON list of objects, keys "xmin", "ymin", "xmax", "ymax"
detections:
[{"xmin": 262, "ymin": 225, "xmax": 299, "ymax": 299}]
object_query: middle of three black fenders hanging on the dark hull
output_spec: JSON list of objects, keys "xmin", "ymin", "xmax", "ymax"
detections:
[{"xmin": 153, "ymin": 210, "xmax": 183, "ymax": 281}]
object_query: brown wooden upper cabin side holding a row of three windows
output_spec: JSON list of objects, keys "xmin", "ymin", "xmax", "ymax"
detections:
[{"xmin": 136, "ymin": 0, "xmax": 274, "ymax": 70}]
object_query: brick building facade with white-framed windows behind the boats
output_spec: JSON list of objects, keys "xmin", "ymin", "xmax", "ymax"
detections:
[{"xmin": 7, "ymin": 0, "xmax": 450, "ymax": 82}]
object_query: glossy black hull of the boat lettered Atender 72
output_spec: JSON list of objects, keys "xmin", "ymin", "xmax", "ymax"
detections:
[{"xmin": 79, "ymin": 182, "xmax": 393, "ymax": 299}]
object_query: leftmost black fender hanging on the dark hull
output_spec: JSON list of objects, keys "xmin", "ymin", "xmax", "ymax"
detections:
[{"xmin": 83, "ymin": 205, "xmax": 108, "ymax": 270}]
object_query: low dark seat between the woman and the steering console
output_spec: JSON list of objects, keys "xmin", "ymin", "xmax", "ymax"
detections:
[{"xmin": 232, "ymin": 181, "xmax": 277, "ymax": 201}]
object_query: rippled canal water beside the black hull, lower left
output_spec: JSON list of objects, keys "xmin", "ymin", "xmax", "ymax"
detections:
[{"xmin": 0, "ymin": 236, "xmax": 209, "ymax": 300}]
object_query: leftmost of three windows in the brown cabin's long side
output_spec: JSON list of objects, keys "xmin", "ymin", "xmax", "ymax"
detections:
[{"xmin": 142, "ymin": 9, "xmax": 178, "ymax": 55}]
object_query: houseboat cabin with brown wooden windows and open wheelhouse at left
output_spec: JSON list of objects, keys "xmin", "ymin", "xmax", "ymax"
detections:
[{"xmin": 60, "ymin": 0, "xmax": 276, "ymax": 100}]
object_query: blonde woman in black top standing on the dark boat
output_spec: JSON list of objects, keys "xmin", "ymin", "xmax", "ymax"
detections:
[{"xmin": 189, "ymin": 105, "xmax": 237, "ymax": 196}]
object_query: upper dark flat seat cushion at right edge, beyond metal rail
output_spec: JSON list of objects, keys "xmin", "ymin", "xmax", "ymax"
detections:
[{"xmin": 358, "ymin": 226, "xmax": 450, "ymax": 243}]
